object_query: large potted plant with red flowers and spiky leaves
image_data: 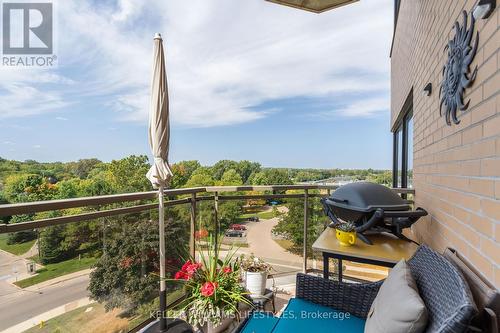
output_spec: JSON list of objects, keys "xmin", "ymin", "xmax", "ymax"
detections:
[{"xmin": 174, "ymin": 240, "xmax": 250, "ymax": 333}]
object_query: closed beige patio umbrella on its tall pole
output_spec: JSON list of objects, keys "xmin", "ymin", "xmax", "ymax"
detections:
[{"xmin": 146, "ymin": 33, "xmax": 172, "ymax": 330}]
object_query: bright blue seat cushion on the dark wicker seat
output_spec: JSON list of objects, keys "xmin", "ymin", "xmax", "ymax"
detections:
[{"xmin": 272, "ymin": 298, "xmax": 365, "ymax": 333}]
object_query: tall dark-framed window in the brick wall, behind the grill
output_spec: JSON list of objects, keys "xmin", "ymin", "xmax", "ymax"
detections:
[{"xmin": 392, "ymin": 93, "xmax": 413, "ymax": 188}]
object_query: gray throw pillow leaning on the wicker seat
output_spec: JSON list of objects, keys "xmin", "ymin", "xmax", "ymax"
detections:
[{"xmin": 365, "ymin": 260, "xmax": 427, "ymax": 333}]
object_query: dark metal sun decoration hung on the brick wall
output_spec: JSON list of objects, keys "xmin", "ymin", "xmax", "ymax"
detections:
[{"xmin": 439, "ymin": 11, "xmax": 479, "ymax": 125}]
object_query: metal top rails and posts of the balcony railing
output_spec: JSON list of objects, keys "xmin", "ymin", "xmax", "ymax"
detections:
[{"xmin": 0, "ymin": 185, "xmax": 414, "ymax": 330}]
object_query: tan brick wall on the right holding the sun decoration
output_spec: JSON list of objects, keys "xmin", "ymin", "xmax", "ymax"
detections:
[{"xmin": 391, "ymin": 0, "xmax": 500, "ymax": 287}]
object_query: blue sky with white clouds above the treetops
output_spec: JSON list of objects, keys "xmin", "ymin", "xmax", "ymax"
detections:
[{"xmin": 0, "ymin": 0, "xmax": 393, "ymax": 169}]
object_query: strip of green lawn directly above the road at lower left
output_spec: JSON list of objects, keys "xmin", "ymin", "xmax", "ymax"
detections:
[{"xmin": 15, "ymin": 258, "xmax": 97, "ymax": 288}]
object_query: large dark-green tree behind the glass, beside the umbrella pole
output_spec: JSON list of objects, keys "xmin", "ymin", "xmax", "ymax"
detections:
[{"xmin": 89, "ymin": 209, "xmax": 189, "ymax": 310}]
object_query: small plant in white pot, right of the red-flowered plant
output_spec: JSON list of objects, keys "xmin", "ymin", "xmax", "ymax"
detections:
[{"xmin": 240, "ymin": 253, "xmax": 271, "ymax": 297}]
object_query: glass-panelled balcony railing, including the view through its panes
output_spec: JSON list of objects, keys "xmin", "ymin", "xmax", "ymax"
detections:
[{"xmin": 0, "ymin": 185, "xmax": 413, "ymax": 332}]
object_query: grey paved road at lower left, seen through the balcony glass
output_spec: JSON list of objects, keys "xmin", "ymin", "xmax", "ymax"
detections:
[{"xmin": 0, "ymin": 275, "xmax": 89, "ymax": 332}]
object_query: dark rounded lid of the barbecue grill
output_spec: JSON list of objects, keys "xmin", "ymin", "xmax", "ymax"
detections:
[{"xmin": 329, "ymin": 182, "xmax": 410, "ymax": 212}]
